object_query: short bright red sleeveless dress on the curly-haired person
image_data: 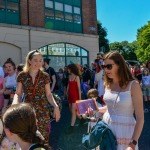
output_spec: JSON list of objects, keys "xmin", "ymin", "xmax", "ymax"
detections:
[{"xmin": 68, "ymin": 77, "xmax": 79, "ymax": 104}]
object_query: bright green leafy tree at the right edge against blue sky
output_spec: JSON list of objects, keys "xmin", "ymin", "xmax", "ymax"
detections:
[{"xmin": 135, "ymin": 21, "xmax": 150, "ymax": 63}]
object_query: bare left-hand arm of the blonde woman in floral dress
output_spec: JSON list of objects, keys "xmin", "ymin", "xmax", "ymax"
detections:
[{"xmin": 12, "ymin": 82, "xmax": 22, "ymax": 105}]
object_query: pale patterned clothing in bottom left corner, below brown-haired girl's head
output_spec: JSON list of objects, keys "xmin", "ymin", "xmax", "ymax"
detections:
[{"xmin": 0, "ymin": 137, "xmax": 21, "ymax": 150}]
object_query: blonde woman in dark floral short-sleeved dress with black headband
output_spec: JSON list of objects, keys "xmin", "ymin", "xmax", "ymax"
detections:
[{"xmin": 13, "ymin": 50, "xmax": 60, "ymax": 144}]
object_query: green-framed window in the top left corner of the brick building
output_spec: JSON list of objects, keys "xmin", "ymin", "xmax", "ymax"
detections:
[{"xmin": 0, "ymin": 0, "xmax": 20, "ymax": 24}]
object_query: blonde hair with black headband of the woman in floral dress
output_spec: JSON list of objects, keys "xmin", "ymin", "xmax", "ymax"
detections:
[{"xmin": 23, "ymin": 50, "xmax": 43, "ymax": 72}]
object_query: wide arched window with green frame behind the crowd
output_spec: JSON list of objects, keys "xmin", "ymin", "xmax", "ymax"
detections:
[{"xmin": 39, "ymin": 43, "xmax": 89, "ymax": 71}]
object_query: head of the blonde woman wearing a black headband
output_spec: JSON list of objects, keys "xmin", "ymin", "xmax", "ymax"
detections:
[{"xmin": 23, "ymin": 50, "xmax": 43, "ymax": 72}]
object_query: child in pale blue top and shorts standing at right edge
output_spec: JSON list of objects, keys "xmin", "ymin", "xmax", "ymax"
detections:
[{"xmin": 142, "ymin": 68, "xmax": 150, "ymax": 112}]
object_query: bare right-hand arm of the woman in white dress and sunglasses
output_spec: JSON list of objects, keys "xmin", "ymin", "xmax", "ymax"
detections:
[{"xmin": 127, "ymin": 81, "xmax": 144, "ymax": 148}]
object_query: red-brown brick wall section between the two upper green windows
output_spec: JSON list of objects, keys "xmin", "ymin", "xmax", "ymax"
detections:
[{"xmin": 20, "ymin": 0, "xmax": 44, "ymax": 27}]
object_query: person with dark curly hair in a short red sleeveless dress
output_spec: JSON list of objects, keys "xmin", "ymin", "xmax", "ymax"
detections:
[{"xmin": 66, "ymin": 64, "xmax": 81, "ymax": 134}]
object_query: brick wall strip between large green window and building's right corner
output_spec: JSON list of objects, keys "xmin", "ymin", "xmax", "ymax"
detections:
[{"xmin": 82, "ymin": 0, "xmax": 97, "ymax": 34}]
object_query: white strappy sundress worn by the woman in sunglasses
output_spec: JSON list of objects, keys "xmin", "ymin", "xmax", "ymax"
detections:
[{"xmin": 103, "ymin": 81, "xmax": 138, "ymax": 150}]
